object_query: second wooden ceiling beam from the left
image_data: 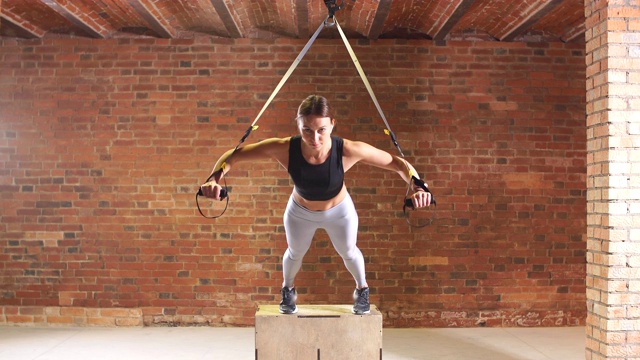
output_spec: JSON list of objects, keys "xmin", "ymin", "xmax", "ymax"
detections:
[{"xmin": 40, "ymin": 0, "xmax": 116, "ymax": 39}]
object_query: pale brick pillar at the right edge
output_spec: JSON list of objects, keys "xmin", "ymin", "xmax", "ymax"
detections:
[{"xmin": 585, "ymin": 0, "xmax": 640, "ymax": 360}]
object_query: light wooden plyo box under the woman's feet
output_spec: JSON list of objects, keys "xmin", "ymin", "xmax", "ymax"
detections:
[{"xmin": 256, "ymin": 305, "xmax": 382, "ymax": 360}]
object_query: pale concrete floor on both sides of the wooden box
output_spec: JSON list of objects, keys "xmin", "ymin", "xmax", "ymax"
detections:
[{"xmin": 0, "ymin": 327, "xmax": 585, "ymax": 360}]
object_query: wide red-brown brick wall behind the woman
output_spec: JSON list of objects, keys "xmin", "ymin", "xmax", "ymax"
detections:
[{"xmin": 0, "ymin": 37, "xmax": 586, "ymax": 327}]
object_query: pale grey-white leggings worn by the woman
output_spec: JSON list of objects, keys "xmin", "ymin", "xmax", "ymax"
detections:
[{"xmin": 282, "ymin": 194, "xmax": 367, "ymax": 287}]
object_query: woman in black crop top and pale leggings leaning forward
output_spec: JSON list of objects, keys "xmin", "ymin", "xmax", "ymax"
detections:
[{"xmin": 201, "ymin": 95, "xmax": 431, "ymax": 315}]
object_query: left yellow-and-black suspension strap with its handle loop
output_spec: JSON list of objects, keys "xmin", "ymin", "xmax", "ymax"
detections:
[{"xmin": 196, "ymin": 16, "xmax": 329, "ymax": 219}]
